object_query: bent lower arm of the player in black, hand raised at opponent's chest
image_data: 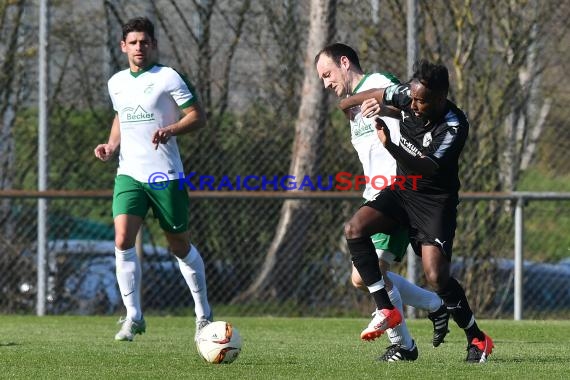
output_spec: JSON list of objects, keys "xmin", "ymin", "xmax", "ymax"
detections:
[{"xmin": 376, "ymin": 118, "xmax": 439, "ymax": 177}]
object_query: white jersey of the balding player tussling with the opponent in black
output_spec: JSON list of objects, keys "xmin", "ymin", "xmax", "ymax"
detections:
[{"xmin": 350, "ymin": 73, "xmax": 400, "ymax": 200}]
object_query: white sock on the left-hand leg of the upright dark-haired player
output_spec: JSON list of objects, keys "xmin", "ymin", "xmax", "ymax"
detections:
[{"xmin": 115, "ymin": 247, "xmax": 142, "ymax": 321}]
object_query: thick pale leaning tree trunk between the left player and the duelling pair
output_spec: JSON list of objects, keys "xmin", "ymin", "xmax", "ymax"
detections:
[{"xmin": 235, "ymin": 0, "xmax": 336, "ymax": 302}]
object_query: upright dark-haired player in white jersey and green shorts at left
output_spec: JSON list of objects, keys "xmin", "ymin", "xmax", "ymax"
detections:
[{"xmin": 95, "ymin": 17, "xmax": 212, "ymax": 341}]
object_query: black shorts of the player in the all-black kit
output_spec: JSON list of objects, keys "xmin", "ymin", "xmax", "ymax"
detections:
[{"xmin": 363, "ymin": 189, "xmax": 459, "ymax": 260}]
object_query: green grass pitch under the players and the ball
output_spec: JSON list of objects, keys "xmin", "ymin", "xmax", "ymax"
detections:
[{"xmin": 0, "ymin": 316, "xmax": 570, "ymax": 380}]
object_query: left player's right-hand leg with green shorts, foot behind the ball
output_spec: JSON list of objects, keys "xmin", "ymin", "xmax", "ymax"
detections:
[{"xmin": 148, "ymin": 181, "xmax": 213, "ymax": 335}]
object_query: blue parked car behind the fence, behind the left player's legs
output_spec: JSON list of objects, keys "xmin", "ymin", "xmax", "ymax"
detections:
[{"xmin": 20, "ymin": 240, "xmax": 191, "ymax": 315}]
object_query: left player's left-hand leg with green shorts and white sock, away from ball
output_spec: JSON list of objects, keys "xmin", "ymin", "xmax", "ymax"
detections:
[{"xmin": 113, "ymin": 175, "xmax": 148, "ymax": 341}]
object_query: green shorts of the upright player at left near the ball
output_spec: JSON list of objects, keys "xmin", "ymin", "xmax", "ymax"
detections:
[{"xmin": 113, "ymin": 175, "xmax": 190, "ymax": 233}]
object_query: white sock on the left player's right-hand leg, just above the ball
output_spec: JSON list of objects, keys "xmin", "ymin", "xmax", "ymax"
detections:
[{"xmin": 176, "ymin": 245, "xmax": 211, "ymax": 319}]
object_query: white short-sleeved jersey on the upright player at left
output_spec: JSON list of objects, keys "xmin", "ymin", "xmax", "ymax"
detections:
[{"xmin": 108, "ymin": 64, "xmax": 197, "ymax": 182}]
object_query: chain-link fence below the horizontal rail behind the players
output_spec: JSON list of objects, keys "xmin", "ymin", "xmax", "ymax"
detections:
[{"xmin": 0, "ymin": 192, "xmax": 570, "ymax": 319}]
